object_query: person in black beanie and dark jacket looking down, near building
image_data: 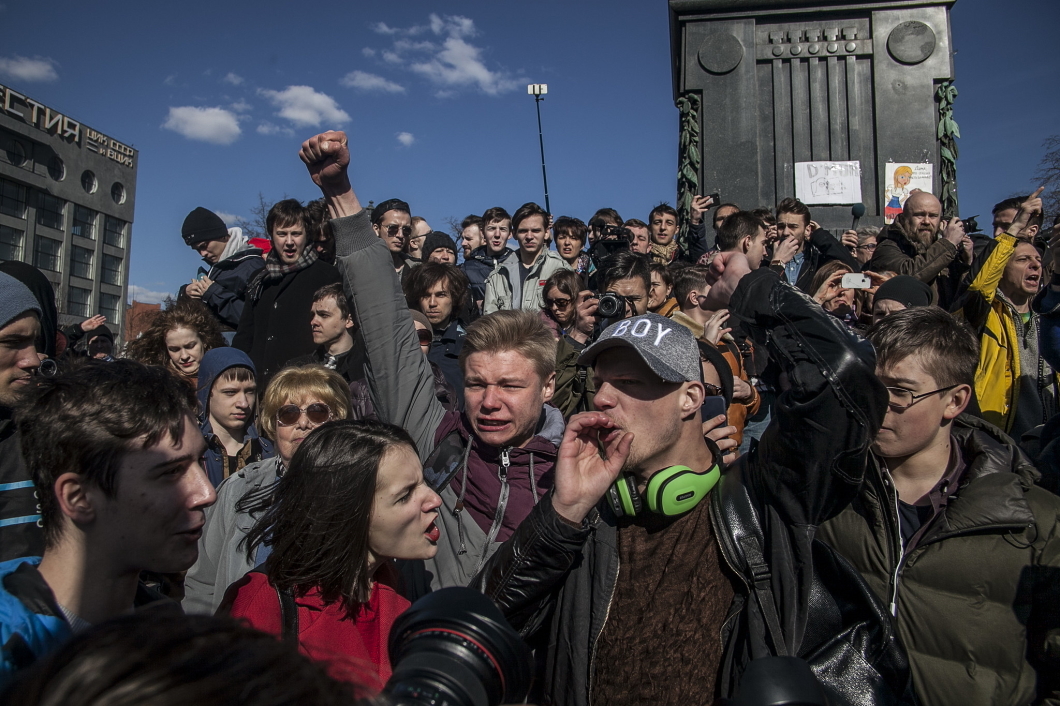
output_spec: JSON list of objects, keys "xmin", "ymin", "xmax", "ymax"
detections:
[{"xmin": 180, "ymin": 206, "xmax": 265, "ymax": 331}]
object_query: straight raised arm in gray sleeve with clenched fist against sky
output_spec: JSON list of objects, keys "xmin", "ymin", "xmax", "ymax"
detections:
[{"xmin": 299, "ymin": 131, "xmax": 445, "ymax": 460}]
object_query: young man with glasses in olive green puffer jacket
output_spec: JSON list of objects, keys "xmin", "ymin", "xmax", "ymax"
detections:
[{"xmin": 817, "ymin": 306, "xmax": 1060, "ymax": 706}]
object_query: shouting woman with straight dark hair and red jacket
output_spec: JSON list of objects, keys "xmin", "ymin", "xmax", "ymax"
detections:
[{"xmin": 218, "ymin": 421, "xmax": 441, "ymax": 689}]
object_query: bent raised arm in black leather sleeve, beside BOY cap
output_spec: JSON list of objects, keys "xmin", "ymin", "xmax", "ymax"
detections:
[{"xmin": 710, "ymin": 253, "xmax": 887, "ymax": 525}]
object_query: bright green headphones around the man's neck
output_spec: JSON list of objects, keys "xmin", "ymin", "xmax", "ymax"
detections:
[{"xmin": 607, "ymin": 462, "xmax": 722, "ymax": 517}]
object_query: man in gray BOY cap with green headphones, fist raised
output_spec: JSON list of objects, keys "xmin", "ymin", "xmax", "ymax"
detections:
[{"xmin": 472, "ymin": 252, "xmax": 911, "ymax": 706}]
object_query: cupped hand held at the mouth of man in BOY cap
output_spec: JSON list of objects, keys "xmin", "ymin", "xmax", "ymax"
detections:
[{"xmin": 552, "ymin": 411, "xmax": 633, "ymax": 523}]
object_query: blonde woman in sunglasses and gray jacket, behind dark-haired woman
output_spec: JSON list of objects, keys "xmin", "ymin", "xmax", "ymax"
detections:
[{"xmin": 182, "ymin": 366, "xmax": 350, "ymax": 614}]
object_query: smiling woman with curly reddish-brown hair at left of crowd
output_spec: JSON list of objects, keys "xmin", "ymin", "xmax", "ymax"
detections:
[{"xmin": 125, "ymin": 299, "xmax": 226, "ymax": 390}]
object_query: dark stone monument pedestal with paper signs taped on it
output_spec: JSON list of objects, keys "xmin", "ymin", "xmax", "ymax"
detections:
[{"xmin": 669, "ymin": 0, "xmax": 955, "ymax": 228}]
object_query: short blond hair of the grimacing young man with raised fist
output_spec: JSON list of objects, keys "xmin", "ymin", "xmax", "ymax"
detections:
[{"xmin": 460, "ymin": 310, "xmax": 555, "ymax": 381}]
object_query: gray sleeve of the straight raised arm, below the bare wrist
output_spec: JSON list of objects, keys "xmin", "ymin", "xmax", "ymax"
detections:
[{"xmin": 331, "ymin": 210, "xmax": 445, "ymax": 461}]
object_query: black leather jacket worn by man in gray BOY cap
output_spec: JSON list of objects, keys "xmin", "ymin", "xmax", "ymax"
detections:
[{"xmin": 473, "ymin": 268, "xmax": 914, "ymax": 706}]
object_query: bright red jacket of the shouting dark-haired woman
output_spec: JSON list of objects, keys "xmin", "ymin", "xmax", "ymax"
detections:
[{"xmin": 218, "ymin": 571, "xmax": 409, "ymax": 693}]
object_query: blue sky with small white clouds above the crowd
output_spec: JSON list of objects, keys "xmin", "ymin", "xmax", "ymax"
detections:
[{"xmin": 0, "ymin": 0, "xmax": 1060, "ymax": 300}]
